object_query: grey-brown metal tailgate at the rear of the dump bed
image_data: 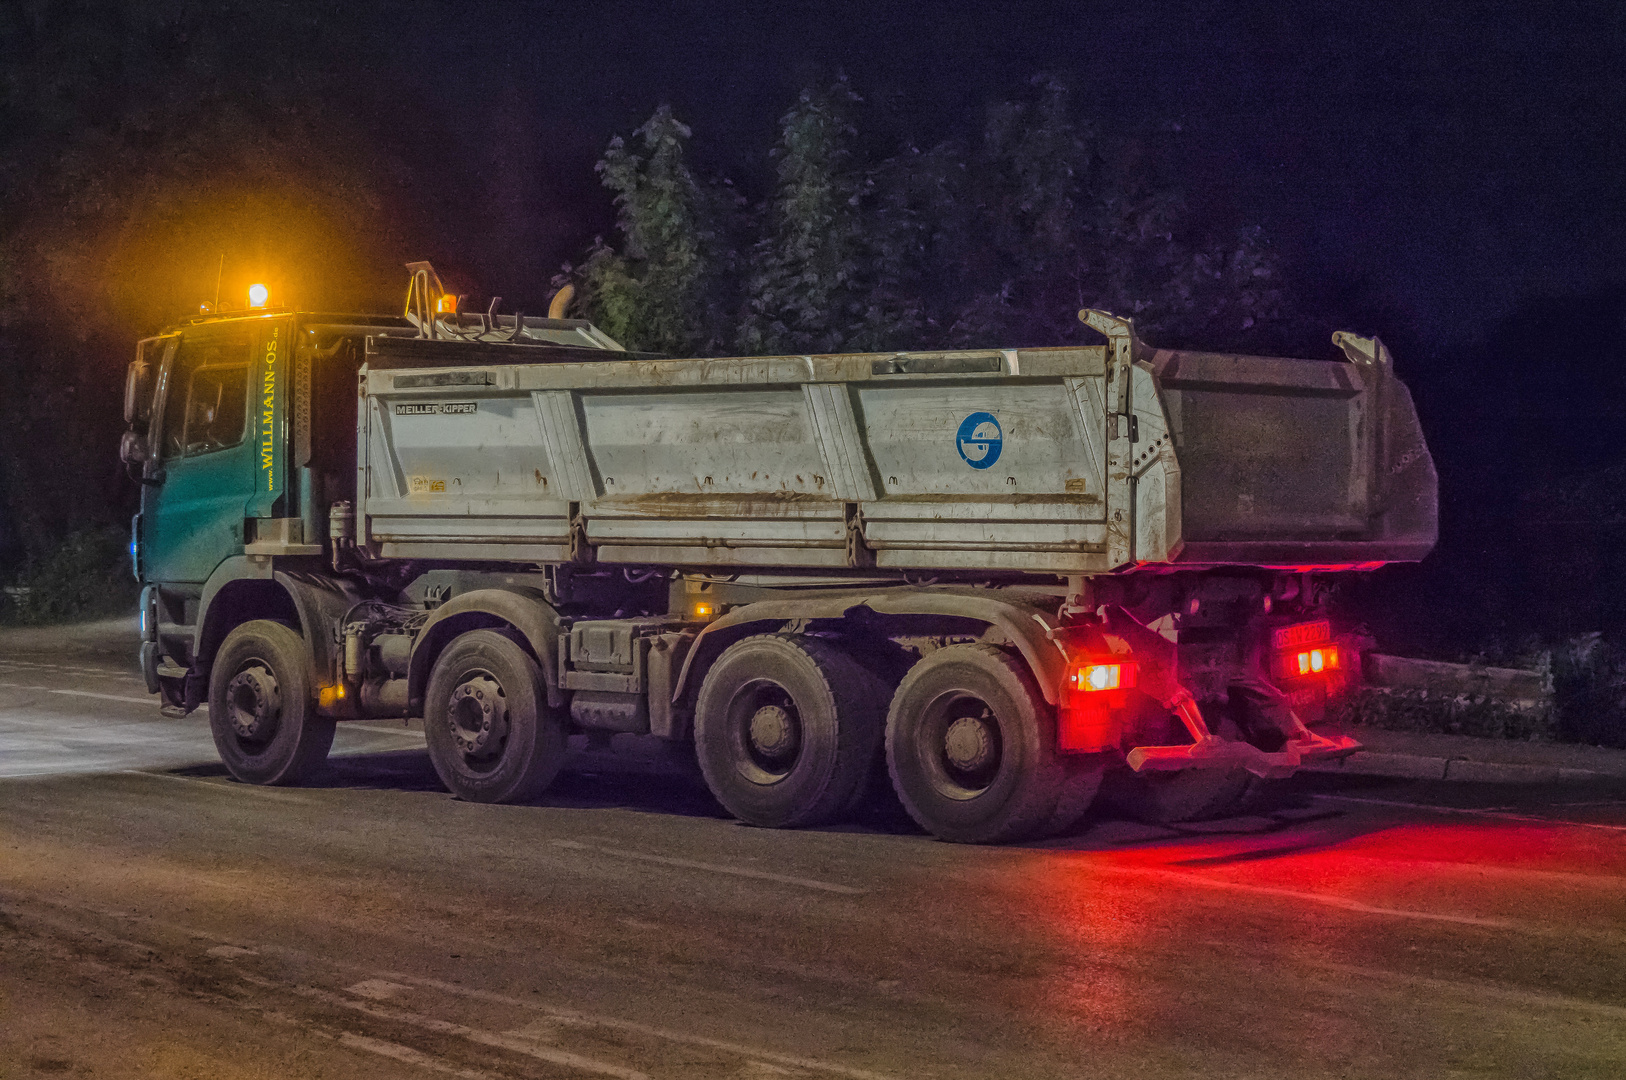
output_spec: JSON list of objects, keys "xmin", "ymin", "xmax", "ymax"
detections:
[{"xmin": 1151, "ymin": 333, "xmax": 1437, "ymax": 568}]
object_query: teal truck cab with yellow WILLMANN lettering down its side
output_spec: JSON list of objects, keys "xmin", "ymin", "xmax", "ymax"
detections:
[{"xmin": 120, "ymin": 311, "xmax": 399, "ymax": 683}]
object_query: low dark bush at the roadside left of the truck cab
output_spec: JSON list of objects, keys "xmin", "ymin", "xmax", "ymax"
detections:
[{"xmin": 0, "ymin": 527, "xmax": 140, "ymax": 625}]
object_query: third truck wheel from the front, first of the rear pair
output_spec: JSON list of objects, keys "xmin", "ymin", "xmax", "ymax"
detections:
[{"xmin": 694, "ymin": 634, "xmax": 885, "ymax": 828}]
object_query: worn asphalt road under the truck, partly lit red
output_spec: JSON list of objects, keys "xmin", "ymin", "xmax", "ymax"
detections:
[{"xmin": 0, "ymin": 626, "xmax": 1626, "ymax": 1080}]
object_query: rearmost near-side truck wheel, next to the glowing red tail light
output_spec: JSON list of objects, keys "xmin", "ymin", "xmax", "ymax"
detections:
[{"xmin": 886, "ymin": 646, "xmax": 1066, "ymax": 844}]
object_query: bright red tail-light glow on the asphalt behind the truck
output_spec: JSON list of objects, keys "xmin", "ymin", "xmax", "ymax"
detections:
[{"xmin": 1002, "ymin": 800, "xmax": 1626, "ymax": 1038}]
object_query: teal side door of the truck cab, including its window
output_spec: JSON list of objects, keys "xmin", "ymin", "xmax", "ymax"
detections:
[{"xmin": 141, "ymin": 320, "xmax": 260, "ymax": 582}]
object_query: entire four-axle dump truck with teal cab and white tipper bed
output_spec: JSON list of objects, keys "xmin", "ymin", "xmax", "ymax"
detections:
[{"xmin": 120, "ymin": 263, "xmax": 1437, "ymax": 843}]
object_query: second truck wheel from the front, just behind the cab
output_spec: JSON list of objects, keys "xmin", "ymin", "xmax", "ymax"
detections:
[{"xmin": 423, "ymin": 629, "xmax": 566, "ymax": 802}]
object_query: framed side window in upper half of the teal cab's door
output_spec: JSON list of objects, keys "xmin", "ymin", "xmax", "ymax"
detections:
[{"xmin": 163, "ymin": 327, "xmax": 254, "ymax": 459}]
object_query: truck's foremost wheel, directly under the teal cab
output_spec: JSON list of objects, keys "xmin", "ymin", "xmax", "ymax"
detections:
[{"xmin": 208, "ymin": 620, "xmax": 333, "ymax": 784}]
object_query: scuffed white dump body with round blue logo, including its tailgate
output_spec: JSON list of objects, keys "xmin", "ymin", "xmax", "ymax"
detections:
[{"xmin": 356, "ymin": 318, "xmax": 1434, "ymax": 574}]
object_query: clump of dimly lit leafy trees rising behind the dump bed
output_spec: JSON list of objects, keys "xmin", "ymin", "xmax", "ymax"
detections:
[{"xmin": 577, "ymin": 76, "xmax": 1289, "ymax": 362}]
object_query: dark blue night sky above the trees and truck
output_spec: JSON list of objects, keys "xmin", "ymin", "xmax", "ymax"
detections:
[{"xmin": 374, "ymin": 0, "xmax": 1626, "ymax": 354}]
